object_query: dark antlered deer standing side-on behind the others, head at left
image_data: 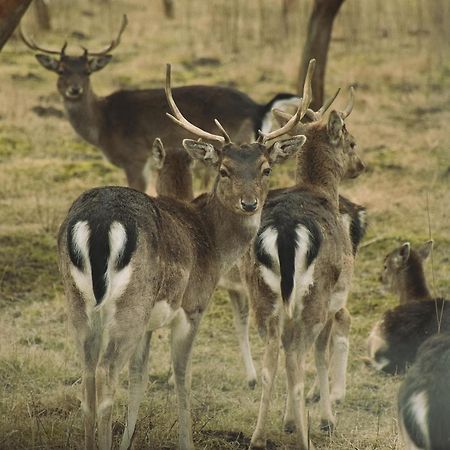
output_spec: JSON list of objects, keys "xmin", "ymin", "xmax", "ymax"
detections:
[{"xmin": 20, "ymin": 15, "xmax": 298, "ymax": 194}]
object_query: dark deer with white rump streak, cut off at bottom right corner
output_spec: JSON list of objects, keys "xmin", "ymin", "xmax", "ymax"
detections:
[{"xmin": 398, "ymin": 332, "xmax": 450, "ymax": 450}]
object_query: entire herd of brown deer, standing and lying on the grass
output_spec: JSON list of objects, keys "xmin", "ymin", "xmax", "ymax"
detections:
[{"xmin": 21, "ymin": 12, "xmax": 450, "ymax": 450}]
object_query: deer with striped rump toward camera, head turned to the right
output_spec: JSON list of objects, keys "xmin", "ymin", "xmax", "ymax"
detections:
[{"xmin": 241, "ymin": 91, "xmax": 364, "ymax": 450}]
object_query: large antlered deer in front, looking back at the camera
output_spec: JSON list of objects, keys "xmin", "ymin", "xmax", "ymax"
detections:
[{"xmin": 58, "ymin": 67, "xmax": 305, "ymax": 450}]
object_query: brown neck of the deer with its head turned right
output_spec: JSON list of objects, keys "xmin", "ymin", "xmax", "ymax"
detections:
[{"xmin": 295, "ymin": 138, "xmax": 343, "ymax": 206}]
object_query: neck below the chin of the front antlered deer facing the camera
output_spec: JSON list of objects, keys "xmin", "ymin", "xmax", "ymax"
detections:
[{"xmin": 203, "ymin": 193, "xmax": 261, "ymax": 273}]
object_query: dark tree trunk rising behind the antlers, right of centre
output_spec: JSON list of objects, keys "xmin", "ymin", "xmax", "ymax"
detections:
[{"xmin": 297, "ymin": 0, "xmax": 345, "ymax": 109}]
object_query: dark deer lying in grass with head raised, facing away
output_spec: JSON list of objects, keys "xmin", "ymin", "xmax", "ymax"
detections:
[{"xmin": 368, "ymin": 241, "xmax": 450, "ymax": 374}]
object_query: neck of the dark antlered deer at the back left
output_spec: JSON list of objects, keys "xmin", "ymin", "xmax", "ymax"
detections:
[{"xmin": 64, "ymin": 85, "xmax": 102, "ymax": 146}]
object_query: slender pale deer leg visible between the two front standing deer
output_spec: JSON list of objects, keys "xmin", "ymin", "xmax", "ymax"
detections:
[{"xmin": 228, "ymin": 290, "xmax": 256, "ymax": 389}]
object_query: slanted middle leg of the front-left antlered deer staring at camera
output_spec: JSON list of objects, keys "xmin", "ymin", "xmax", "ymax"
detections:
[{"xmin": 120, "ymin": 331, "xmax": 152, "ymax": 450}]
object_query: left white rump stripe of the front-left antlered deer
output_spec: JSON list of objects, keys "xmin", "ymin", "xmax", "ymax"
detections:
[{"xmin": 68, "ymin": 220, "xmax": 95, "ymax": 305}]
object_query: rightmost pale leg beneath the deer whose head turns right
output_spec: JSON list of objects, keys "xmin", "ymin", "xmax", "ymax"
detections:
[{"xmin": 330, "ymin": 308, "xmax": 351, "ymax": 402}]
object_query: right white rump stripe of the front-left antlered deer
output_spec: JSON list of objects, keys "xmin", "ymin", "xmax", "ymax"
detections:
[{"xmin": 99, "ymin": 222, "xmax": 132, "ymax": 308}]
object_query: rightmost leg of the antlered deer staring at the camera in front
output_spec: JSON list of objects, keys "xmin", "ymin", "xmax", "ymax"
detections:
[{"xmin": 171, "ymin": 310, "xmax": 201, "ymax": 450}]
